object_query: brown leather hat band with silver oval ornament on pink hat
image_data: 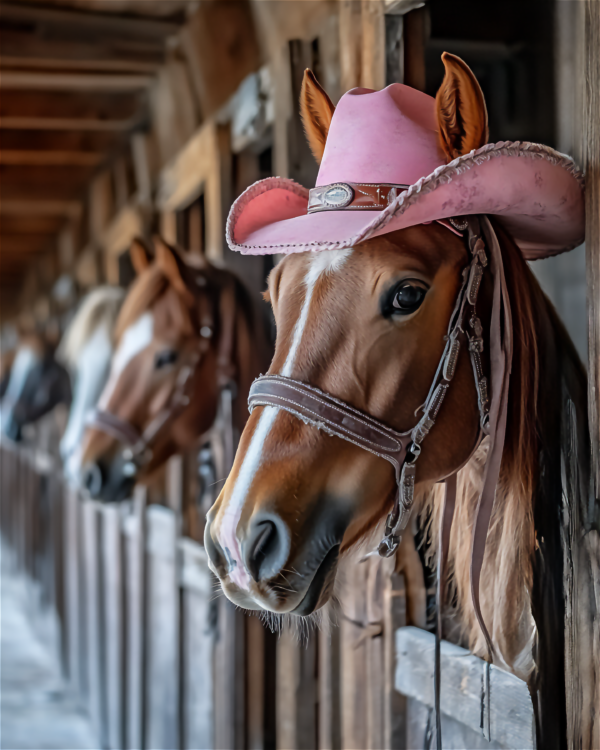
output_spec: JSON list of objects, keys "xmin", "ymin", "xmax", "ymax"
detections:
[{"xmin": 308, "ymin": 182, "xmax": 409, "ymax": 214}]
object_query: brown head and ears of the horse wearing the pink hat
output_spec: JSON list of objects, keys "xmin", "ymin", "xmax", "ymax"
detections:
[{"xmin": 205, "ymin": 56, "xmax": 490, "ymax": 615}]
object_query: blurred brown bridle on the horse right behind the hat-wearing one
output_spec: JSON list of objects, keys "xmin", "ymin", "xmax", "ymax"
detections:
[{"xmin": 86, "ymin": 269, "xmax": 236, "ymax": 475}]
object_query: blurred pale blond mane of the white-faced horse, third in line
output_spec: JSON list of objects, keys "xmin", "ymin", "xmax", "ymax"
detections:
[{"xmin": 56, "ymin": 286, "xmax": 125, "ymax": 369}]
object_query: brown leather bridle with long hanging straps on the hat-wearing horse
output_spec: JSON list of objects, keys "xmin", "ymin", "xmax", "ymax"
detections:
[{"xmin": 248, "ymin": 216, "xmax": 512, "ymax": 748}]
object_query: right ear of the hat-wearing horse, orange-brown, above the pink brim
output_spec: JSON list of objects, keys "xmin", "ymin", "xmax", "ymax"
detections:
[{"xmin": 435, "ymin": 52, "xmax": 489, "ymax": 161}]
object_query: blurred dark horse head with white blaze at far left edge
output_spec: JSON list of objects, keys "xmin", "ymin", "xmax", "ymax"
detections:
[{"xmin": 2, "ymin": 330, "xmax": 71, "ymax": 442}]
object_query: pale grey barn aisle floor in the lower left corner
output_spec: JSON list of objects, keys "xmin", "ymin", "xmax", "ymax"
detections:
[{"xmin": 0, "ymin": 548, "xmax": 99, "ymax": 750}]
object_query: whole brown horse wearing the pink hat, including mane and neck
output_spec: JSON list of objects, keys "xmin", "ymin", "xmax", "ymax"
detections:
[{"xmin": 205, "ymin": 57, "xmax": 589, "ymax": 747}]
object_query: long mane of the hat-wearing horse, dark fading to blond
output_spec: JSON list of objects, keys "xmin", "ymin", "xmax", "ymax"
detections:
[{"xmin": 420, "ymin": 222, "xmax": 586, "ymax": 680}]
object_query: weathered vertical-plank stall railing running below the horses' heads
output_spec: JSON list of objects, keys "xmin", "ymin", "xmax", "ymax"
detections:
[{"xmin": 0, "ymin": 444, "xmax": 533, "ymax": 750}]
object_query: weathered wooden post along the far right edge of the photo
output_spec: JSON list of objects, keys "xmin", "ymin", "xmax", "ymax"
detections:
[{"xmin": 576, "ymin": 0, "xmax": 600, "ymax": 747}]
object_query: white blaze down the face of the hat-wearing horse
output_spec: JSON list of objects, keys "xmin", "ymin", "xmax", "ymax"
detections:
[{"xmin": 218, "ymin": 248, "xmax": 352, "ymax": 590}]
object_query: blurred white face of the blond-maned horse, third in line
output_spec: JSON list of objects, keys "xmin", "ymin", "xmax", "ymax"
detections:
[{"xmin": 60, "ymin": 326, "xmax": 113, "ymax": 481}]
